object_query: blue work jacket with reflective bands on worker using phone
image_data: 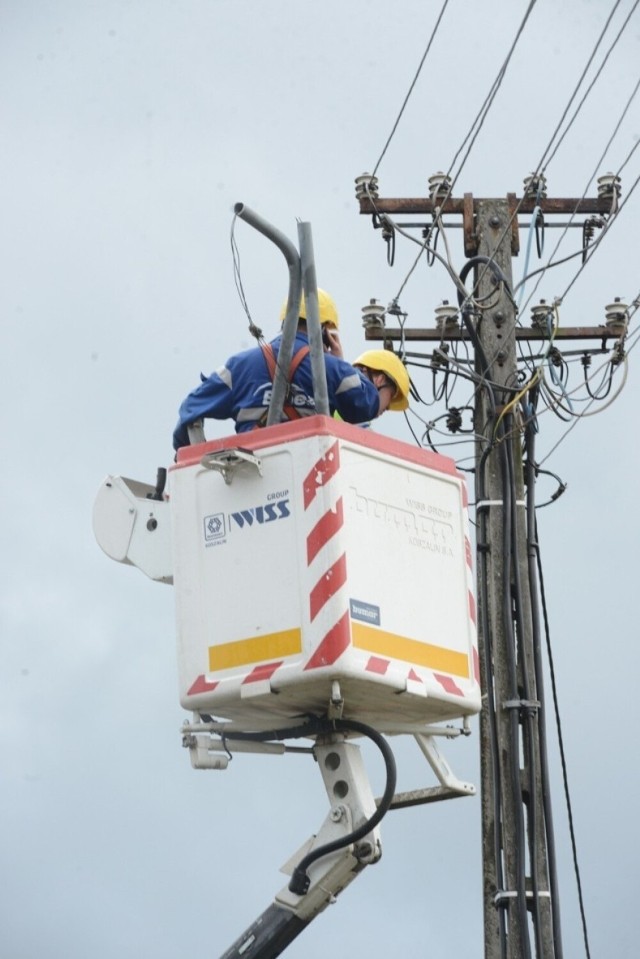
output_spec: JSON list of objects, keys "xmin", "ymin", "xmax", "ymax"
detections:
[{"xmin": 173, "ymin": 332, "xmax": 380, "ymax": 449}]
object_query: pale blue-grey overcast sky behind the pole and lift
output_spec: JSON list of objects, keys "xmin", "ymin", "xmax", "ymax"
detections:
[{"xmin": 0, "ymin": 0, "xmax": 640, "ymax": 959}]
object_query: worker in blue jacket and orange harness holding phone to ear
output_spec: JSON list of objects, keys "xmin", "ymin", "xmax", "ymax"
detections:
[{"xmin": 173, "ymin": 290, "xmax": 399, "ymax": 449}]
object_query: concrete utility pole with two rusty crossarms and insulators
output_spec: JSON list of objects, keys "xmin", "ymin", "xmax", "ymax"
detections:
[{"xmin": 356, "ymin": 174, "xmax": 619, "ymax": 959}]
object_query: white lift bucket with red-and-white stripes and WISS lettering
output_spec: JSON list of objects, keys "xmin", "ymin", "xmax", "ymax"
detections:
[{"xmin": 170, "ymin": 416, "xmax": 480, "ymax": 732}]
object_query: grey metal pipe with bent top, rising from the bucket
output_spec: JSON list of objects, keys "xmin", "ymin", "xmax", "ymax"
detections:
[{"xmin": 233, "ymin": 203, "xmax": 302, "ymax": 426}]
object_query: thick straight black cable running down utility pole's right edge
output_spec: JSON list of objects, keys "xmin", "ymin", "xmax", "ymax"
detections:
[{"xmin": 525, "ymin": 414, "xmax": 563, "ymax": 959}]
